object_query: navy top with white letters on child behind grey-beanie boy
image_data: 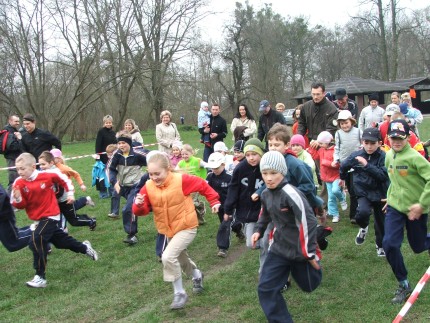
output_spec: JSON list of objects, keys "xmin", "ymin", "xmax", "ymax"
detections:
[{"xmin": 224, "ymin": 159, "xmax": 264, "ymax": 223}]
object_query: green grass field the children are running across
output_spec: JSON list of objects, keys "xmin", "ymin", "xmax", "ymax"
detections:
[{"xmin": 0, "ymin": 118, "xmax": 430, "ymax": 322}]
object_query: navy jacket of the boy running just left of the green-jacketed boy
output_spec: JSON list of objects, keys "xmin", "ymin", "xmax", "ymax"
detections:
[{"xmin": 340, "ymin": 149, "xmax": 390, "ymax": 202}]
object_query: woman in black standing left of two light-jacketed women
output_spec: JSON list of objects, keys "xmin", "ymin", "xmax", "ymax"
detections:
[{"xmin": 95, "ymin": 115, "xmax": 117, "ymax": 199}]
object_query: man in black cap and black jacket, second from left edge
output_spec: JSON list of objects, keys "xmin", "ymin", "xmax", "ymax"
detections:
[{"xmin": 21, "ymin": 113, "xmax": 61, "ymax": 160}]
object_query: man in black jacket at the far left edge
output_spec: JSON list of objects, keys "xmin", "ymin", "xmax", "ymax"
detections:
[{"xmin": 4, "ymin": 115, "xmax": 22, "ymax": 194}]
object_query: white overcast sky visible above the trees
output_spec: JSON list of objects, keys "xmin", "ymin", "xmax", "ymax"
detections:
[{"xmin": 202, "ymin": 0, "xmax": 429, "ymax": 41}]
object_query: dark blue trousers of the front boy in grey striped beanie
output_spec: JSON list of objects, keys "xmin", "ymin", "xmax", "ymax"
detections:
[{"xmin": 258, "ymin": 251, "xmax": 322, "ymax": 322}]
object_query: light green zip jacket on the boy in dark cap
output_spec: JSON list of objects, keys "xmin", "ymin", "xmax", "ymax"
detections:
[{"xmin": 385, "ymin": 144, "xmax": 430, "ymax": 214}]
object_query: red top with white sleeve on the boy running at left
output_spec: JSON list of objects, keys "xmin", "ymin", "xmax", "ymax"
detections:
[{"xmin": 12, "ymin": 171, "xmax": 74, "ymax": 221}]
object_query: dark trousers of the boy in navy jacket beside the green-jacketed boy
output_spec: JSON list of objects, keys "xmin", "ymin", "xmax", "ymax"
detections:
[{"xmin": 355, "ymin": 197, "xmax": 385, "ymax": 248}]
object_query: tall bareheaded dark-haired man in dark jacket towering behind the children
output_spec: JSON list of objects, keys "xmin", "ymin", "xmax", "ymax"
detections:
[{"xmin": 297, "ymin": 83, "xmax": 338, "ymax": 149}]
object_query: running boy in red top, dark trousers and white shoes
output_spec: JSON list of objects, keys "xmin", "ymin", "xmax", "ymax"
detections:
[{"xmin": 12, "ymin": 153, "xmax": 98, "ymax": 288}]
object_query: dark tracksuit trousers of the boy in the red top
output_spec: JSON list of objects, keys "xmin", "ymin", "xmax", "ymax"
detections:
[{"xmin": 29, "ymin": 218, "xmax": 87, "ymax": 278}]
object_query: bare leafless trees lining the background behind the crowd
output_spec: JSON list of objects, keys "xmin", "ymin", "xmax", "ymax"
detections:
[{"xmin": 0, "ymin": 0, "xmax": 430, "ymax": 140}]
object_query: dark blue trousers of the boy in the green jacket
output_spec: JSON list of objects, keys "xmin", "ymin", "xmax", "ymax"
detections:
[{"xmin": 382, "ymin": 206, "xmax": 430, "ymax": 282}]
